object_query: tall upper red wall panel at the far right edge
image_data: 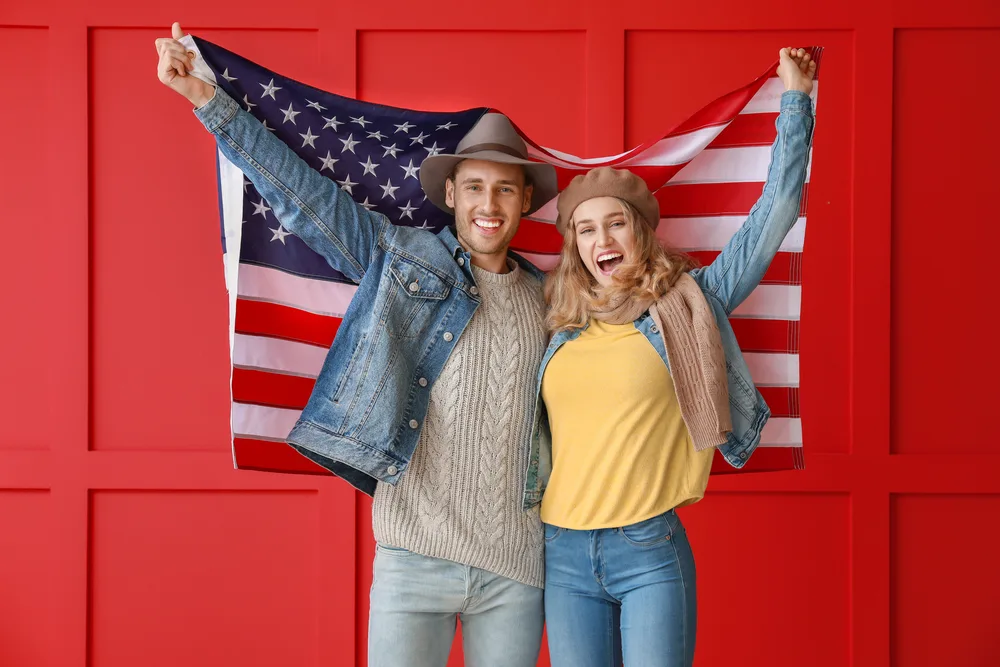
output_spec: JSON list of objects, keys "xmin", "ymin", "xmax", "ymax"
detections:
[{"xmin": 891, "ymin": 30, "xmax": 1000, "ymax": 454}]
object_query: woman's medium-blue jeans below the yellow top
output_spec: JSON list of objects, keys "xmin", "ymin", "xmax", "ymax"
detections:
[{"xmin": 545, "ymin": 510, "xmax": 697, "ymax": 667}]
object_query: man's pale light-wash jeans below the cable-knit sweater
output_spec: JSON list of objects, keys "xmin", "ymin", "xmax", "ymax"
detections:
[{"xmin": 368, "ymin": 545, "xmax": 544, "ymax": 667}]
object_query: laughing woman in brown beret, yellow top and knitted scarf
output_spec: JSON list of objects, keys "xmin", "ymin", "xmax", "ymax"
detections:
[{"xmin": 529, "ymin": 49, "xmax": 816, "ymax": 667}]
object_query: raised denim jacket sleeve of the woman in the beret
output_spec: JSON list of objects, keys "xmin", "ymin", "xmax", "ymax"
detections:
[{"xmin": 691, "ymin": 90, "xmax": 814, "ymax": 313}]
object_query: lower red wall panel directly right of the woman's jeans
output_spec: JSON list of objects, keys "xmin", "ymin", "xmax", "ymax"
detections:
[{"xmin": 680, "ymin": 492, "xmax": 851, "ymax": 667}]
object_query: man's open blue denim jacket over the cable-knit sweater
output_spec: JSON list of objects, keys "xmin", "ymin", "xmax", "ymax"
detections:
[{"xmin": 195, "ymin": 88, "xmax": 543, "ymax": 495}]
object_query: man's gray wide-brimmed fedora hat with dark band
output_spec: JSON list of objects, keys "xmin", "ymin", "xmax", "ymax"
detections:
[{"xmin": 420, "ymin": 113, "xmax": 559, "ymax": 213}]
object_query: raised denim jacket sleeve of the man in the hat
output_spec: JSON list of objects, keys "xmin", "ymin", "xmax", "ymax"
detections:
[{"xmin": 194, "ymin": 88, "xmax": 389, "ymax": 282}]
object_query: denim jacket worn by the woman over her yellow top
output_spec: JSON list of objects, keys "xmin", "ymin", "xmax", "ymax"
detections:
[{"xmin": 524, "ymin": 91, "xmax": 813, "ymax": 508}]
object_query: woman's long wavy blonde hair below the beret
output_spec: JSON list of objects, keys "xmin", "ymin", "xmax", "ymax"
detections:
[{"xmin": 545, "ymin": 197, "xmax": 695, "ymax": 333}]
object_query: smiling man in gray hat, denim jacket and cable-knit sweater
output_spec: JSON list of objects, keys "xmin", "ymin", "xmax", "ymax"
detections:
[{"xmin": 156, "ymin": 24, "xmax": 557, "ymax": 667}]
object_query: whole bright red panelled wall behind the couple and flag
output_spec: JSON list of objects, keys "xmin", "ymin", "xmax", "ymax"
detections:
[{"xmin": 0, "ymin": 0, "xmax": 1000, "ymax": 667}]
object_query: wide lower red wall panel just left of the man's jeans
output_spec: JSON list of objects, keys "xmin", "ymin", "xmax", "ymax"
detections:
[{"xmin": 90, "ymin": 491, "xmax": 322, "ymax": 667}]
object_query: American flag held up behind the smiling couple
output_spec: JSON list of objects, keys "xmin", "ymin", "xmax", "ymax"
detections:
[{"xmin": 182, "ymin": 36, "xmax": 822, "ymax": 474}]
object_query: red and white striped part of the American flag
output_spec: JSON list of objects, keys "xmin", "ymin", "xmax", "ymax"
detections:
[{"xmin": 219, "ymin": 50, "xmax": 820, "ymax": 474}]
